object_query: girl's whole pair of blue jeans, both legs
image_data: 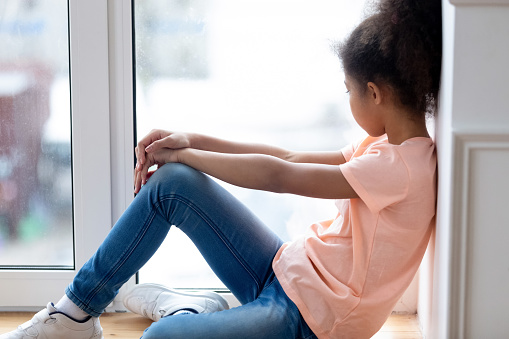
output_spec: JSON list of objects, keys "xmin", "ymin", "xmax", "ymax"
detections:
[{"xmin": 66, "ymin": 164, "xmax": 316, "ymax": 339}]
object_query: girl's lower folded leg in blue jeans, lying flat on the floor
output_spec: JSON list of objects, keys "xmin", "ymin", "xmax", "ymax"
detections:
[{"xmin": 138, "ymin": 278, "xmax": 316, "ymax": 339}]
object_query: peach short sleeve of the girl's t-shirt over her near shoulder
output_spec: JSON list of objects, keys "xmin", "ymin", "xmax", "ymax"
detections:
[{"xmin": 340, "ymin": 143, "xmax": 409, "ymax": 213}]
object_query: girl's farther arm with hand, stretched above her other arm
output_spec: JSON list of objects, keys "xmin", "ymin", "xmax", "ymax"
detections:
[{"xmin": 136, "ymin": 130, "xmax": 345, "ymax": 168}]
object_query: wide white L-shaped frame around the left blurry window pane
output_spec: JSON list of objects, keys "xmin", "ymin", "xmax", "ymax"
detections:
[{"xmin": 0, "ymin": 0, "xmax": 112, "ymax": 311}]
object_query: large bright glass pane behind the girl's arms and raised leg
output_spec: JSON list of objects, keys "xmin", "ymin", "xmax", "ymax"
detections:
[{"xmin": 135, "ymin": 0, "xmax": 363, "ymax": 288}]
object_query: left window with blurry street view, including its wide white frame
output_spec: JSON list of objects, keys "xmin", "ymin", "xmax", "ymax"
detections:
[{"xmin": 0, "ymin": 0, "xmax": 111, "ymax": 310}]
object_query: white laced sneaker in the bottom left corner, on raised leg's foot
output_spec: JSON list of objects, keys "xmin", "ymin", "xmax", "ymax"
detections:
[{"xmin": 0, "ymin": 303, "xmax": 104, "ymax": 339}]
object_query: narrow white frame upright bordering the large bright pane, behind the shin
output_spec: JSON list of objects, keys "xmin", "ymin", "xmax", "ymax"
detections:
[{"xmin": 106, "ymin": 0, "xmax": 136, "ymax": 312}]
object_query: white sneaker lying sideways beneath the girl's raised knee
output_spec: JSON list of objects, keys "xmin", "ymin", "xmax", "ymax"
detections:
[{"xmin": 123, "ymin": 284, "xmax": 229, "ymax": 322}]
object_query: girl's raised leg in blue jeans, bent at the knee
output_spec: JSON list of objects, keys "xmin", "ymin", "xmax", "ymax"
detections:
[{"xmin": 66, "ymin": 164, "xmax": 282, "ymax": 316}]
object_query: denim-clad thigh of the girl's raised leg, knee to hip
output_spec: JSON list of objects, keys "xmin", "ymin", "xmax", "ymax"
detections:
[{"xmin": 149, "ymin": 164, "xmax": 283, "ymax": 304}]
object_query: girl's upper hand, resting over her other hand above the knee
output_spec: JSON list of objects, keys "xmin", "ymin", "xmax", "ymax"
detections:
[{"xmin": 135, "ymin": 129, "xmax": 191, "ymax": 171}]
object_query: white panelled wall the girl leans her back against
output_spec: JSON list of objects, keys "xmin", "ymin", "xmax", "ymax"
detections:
[{"xmin": 419, "ymin": 0, "xmax": 509, "ymax": 338}]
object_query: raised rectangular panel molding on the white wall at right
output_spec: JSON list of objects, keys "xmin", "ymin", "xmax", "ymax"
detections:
[{"xmin": 448, "ymin": 131, "xmax": 509, "ymax": 338}]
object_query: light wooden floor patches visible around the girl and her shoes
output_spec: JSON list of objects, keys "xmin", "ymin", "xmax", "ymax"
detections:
[{"xmin": 0, "ymin": 312, "xmax": 422, "ymax": 339}]
